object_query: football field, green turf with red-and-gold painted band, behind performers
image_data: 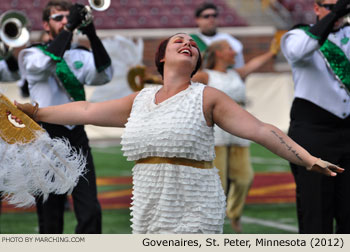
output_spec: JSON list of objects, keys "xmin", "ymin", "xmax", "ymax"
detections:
[{"xmin": 0, "ymin": 143, "xmax": 297, "ymax": 234}]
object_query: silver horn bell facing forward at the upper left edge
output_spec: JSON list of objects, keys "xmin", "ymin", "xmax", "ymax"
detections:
[{"xmin": 0, "ymin": 10, "xmax": 30, "ymax": 58}]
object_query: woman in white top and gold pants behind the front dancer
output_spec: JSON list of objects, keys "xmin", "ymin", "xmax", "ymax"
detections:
[{"xmin": 192, "ymin": 40, "xmax": 279, "ymax": 233}]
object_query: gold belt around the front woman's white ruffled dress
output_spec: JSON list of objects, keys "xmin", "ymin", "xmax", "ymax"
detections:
[{"xmin": 136, "ymin": 157, "xmax": 214, "ymax": 169}]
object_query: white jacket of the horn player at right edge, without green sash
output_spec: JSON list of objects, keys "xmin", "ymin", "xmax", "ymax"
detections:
[{"xmin": 281, "ymin": 26, "xmax": 350, "ymax": 118}]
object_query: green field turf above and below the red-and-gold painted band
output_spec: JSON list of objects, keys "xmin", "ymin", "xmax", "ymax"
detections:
[{"xmin": 0, "ymin": 143, "xmax": 297, "ymax": 234}]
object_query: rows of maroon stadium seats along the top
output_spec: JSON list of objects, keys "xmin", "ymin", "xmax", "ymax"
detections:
[{"xmin": 0, "ymin": 0, "xmax": 247, "ymax": 30}]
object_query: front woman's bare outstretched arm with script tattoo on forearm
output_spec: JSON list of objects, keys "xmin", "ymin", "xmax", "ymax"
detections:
[{"xmin": 204, "ymin": 87, "xmax": 343, "ymax": 176}]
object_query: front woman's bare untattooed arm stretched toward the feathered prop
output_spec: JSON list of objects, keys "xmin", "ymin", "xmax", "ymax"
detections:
[{"xmin": 15, "ymin": 93, "xmax": 137, "ymax": 127}]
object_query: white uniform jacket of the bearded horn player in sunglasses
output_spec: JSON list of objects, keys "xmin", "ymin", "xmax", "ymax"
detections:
[{"xmin": 18, "ymin": 46, "xmax": 113, "ymax": 107}]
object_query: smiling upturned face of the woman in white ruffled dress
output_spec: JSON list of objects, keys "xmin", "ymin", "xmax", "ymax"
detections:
[{"xmin": 163, "ymin": 33, "xmax": 199, "ymax": 70}]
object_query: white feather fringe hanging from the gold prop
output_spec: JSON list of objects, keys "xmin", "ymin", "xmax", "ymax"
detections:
[{"xmin": 0, "ymin": 131, "xmax": 86, "ymax": 207}]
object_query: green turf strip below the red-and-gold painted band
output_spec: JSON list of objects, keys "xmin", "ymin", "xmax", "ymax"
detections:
[{"xmin": 0, "ymin": 207, "xmax": 296, "ymax": 234}]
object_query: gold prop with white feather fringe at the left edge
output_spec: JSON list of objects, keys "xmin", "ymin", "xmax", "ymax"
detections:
[{"xmin": 0, "ymin": 93, "xmax": 86, "ymax": 207}]
